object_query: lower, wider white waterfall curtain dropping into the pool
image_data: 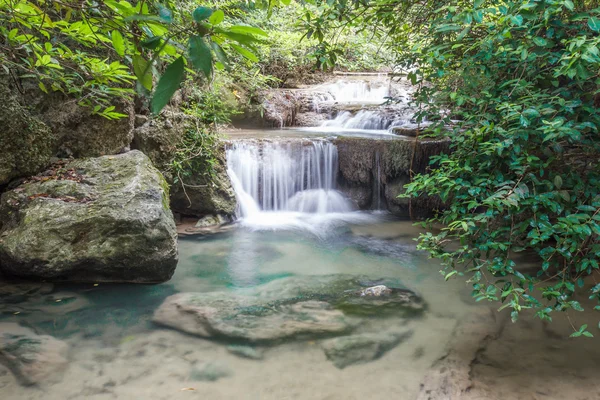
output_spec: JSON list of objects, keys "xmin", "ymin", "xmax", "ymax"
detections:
[{"xmin": 227, "ymin": 141, "xmax": 352, "ymax": 218}]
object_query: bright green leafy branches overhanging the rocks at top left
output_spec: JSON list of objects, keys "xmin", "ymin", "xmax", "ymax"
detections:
[{"xmin": 0, "ymin": 0, "xmax": 266, "ymax": 118}]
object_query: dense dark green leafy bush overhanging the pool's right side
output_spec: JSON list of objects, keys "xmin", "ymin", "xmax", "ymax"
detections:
[{"xmin": 306, "ymin": 0, "xmax": 600, "ymax": 336}]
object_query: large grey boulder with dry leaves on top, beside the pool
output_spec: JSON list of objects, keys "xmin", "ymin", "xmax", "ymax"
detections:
[{"xmin": 0, "ymin": 151, "xmax": 177, "ymax": 283}]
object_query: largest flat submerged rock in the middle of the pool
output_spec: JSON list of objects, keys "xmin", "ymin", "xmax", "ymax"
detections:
[{"xmin": 154, "ymin": 275, "xmax": 424, "ymax": 342}]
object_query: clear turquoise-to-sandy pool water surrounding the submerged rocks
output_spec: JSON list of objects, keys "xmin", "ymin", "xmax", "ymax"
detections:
[{"xmin": 0, "ymin": 214, "xmax": 482, "ymax": 400}]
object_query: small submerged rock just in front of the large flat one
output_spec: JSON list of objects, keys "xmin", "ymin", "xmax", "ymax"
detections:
[{"xmin": 322, "ymin": 330, "xmax": 412, "ymax": 369}]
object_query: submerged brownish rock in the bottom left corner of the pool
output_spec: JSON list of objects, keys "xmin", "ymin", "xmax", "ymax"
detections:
[{"xmin": 0, "ymin": 322, "xmax": 68, "ymax": 385}]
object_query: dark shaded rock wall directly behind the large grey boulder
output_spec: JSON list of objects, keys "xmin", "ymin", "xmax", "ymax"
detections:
[{"xmin": 0, "ymin": 73, "xmax": 133, "ymax": 185}]
